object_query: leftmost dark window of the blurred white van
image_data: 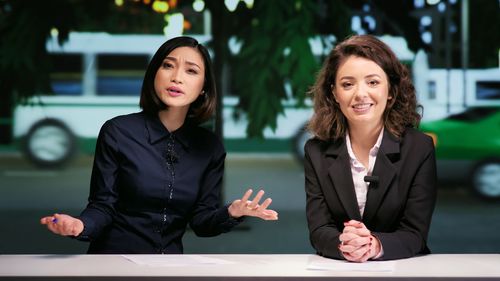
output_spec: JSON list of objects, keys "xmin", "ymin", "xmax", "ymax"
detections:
[{"xmin": 50, "ymin": 54, "xmax": 82, "ymax": 96}]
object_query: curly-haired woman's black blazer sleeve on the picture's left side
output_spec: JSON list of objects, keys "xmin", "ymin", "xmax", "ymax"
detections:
[{"xmin": 304, "ymin": 140, "xmax": 344, "ymax": 259}]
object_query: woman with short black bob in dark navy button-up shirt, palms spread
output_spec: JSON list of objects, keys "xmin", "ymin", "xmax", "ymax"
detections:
[{"xmin": 40, "ymin": 37, "xmax": 278, "ymax": 254}]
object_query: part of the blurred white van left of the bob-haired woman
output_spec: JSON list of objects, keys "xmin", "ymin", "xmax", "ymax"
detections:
[{"xmin": 13, "ymin": 33, "xmax": 209, "ymax": 167}]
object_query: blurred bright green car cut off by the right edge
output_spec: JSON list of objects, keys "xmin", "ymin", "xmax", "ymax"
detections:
[{"xmin": 420, "ymin": 107, "xmax": 500, "ymax": 199}]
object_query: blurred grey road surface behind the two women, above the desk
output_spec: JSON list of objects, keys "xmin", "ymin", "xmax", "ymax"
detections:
[{"xmin": 0, "ymin": 154, "xmax": 500, "ymax": 254}]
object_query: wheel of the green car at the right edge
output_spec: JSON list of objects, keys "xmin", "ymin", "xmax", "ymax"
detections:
[{"xmin": 472, "ymin": 159, "xmax": 500, "ymax": 199}]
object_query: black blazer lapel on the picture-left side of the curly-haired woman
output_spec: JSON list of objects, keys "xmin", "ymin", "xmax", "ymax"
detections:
[{"xmin": 326, "ymin": 141, "xmax": 361, "ymax": 220}]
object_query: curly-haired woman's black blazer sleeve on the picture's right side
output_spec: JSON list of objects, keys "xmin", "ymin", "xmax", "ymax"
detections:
[{"xmin": 372, "ymin": 136, "xmax": 437, "ymax": 260}]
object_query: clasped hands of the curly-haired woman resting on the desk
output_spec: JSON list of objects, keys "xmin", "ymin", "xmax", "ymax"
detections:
[{"xmin": 339, "ymin": 220, "xmax": 381, "ymax": 262}]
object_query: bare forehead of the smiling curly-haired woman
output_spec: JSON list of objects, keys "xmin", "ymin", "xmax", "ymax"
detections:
[{"xmin": 337, "ymin": 56, "xmax": 386, "ymax": 78}]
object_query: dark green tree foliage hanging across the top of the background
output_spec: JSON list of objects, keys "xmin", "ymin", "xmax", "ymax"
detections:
[{"xmin": 0, "ymin": 0, "xmax": 500, "ymax": 137}]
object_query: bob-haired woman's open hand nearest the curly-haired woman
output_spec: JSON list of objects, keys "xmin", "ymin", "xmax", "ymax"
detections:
[{"xmin": 228, "ymin": 189, "xmax": 278, "ymax": 220}]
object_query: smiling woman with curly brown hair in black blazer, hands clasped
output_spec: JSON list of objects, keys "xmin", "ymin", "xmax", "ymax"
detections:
[{"xmin": 304, "ymin": 35, "xmax": 436, "ymax": 262}]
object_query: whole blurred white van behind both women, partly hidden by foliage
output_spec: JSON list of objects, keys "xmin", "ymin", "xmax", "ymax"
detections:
[{"xmin": 13, "ymin": 33, "xmax": 422, "ymax": 167}]
